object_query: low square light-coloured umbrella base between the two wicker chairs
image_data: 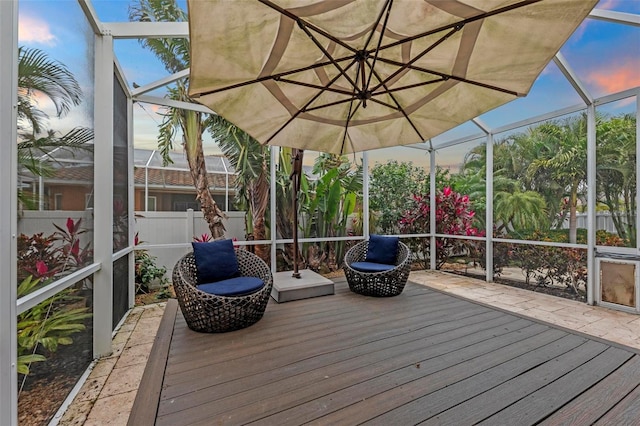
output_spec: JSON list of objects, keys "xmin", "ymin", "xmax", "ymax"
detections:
[{"xmin": 271, "ymin": 269, "xmax": 335, "ymax": 303}]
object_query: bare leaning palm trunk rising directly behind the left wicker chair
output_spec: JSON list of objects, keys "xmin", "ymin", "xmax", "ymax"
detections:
[{"xmin": 185, "ymin": 136, "xmax": 227, "ymax": 240}]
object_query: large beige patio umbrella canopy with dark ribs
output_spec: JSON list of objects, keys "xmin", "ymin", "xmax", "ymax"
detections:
[{"xmin": 187, "ymin": 0, "xmax": 598, "ymax": 276}]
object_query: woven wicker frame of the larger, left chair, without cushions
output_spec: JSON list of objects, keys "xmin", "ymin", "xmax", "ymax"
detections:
[{"xmin": 173, "ymin": 249, "xmax": 273, "ymax": 333}]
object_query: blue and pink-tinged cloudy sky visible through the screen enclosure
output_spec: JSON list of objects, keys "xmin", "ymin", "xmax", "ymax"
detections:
[{"xmin": 15, "ymin": 0, "xmax": 640, "ymax": 170}]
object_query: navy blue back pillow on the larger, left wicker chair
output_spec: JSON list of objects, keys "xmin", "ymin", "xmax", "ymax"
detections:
[{"xmin": 191, "ymin": 239, "xmax": 240, "ymax": 284}]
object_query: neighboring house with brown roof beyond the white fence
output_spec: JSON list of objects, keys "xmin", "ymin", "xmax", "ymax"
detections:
[{"xmin": 21, "ymin": 149, "xmax": 236, "ymax": 211}]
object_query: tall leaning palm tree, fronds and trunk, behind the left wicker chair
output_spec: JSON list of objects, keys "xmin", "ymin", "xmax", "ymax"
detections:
[{"xmin": 129, "ymin": 0, "xmax": 226, "ymax": 239}]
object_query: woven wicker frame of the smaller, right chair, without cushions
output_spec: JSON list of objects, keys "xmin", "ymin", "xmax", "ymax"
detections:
[{"xmin": 343, "ymin": 241, "xmax": 411, "ymax": 297}]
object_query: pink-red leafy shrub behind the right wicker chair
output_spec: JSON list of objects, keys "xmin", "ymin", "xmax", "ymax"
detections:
[{"xmin": 399, "ymin": 187, "xmax": 484, "ymax": 269}]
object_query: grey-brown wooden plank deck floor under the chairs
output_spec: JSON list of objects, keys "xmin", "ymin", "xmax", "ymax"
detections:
[{"xmin": 129, "ymin": 281, "xmax": 640, "ymax": 426}]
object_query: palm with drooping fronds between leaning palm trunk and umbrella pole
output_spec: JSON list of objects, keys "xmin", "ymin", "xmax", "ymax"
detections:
[{"xmin": 209, "ymin": 115, "xmax": 269, "ymax": 262}]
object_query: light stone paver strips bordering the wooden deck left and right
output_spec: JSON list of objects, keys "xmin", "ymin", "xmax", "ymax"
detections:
[{"xmin": 59, "ymin": 271, "xmax": 640, "ymax": 426}]
